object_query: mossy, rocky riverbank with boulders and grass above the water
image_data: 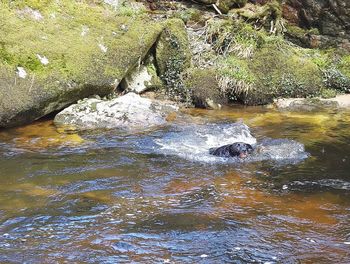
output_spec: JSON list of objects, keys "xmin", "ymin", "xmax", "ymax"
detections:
[{"xmin": 0, "ymin": 0, "xmax": 350, "ymax": 127}]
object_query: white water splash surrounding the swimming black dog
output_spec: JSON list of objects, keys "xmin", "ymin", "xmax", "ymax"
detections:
[{"xmin": 155, "ymin": 122, "xmax": 308, "ymax": 163}]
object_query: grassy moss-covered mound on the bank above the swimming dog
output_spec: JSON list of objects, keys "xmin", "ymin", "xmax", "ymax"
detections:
[{"xmin": 207, "ymin": 20, "xmax": 324, "ymax": 105}]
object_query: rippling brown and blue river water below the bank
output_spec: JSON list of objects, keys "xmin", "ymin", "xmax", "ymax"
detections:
[{"xmin": 0, "ymin": 107, "xmax": 350, "ymax": 263}]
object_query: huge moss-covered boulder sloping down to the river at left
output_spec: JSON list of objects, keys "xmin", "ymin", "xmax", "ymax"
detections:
[{"xmin": 0, "ymin": 0, "xmax": 163, "ymax": 127}]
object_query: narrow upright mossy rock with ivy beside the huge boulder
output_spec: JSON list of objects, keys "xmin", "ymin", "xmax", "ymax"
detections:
[{"xmin": 156, "ymin": 19, "xmax": 191, "ymax": 99}]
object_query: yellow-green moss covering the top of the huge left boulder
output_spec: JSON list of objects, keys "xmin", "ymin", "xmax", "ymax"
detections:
[{"xmin": 0, "ymin": 0, "xmax": 161, "ymax": 81}]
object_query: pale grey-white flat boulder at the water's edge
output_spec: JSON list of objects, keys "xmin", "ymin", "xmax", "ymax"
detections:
[{"xmin": 54, "ymin": 93, "xmax": 178, "ymax": 130}]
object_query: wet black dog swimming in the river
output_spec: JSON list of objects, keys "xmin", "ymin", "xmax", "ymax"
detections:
[{"xmin": 209, "ymin": 142, "xmax": 253, "ymax": 159}]
